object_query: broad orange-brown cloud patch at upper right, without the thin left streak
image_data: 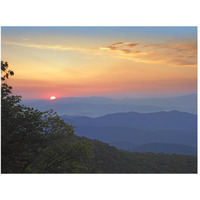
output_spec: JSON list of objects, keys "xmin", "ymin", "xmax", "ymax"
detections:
[{"xmin": 101, "ymin": 39, "xmax": 197, "ymax": 67}]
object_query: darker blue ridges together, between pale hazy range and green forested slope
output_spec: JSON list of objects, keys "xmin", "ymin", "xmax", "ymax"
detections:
[{"xmin": 61, "ymin": 111, "xmax": 197, "ymax": 155}]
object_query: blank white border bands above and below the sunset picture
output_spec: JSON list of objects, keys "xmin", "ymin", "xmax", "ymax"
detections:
[{"xmin": 0, "ymin": 0, "xmax": 200, "ymax": 200}]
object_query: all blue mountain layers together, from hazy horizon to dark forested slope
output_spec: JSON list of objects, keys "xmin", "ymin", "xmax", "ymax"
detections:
[{"xmin": 22, "ymin": 94, "xmax": 197, "ymax": 155}]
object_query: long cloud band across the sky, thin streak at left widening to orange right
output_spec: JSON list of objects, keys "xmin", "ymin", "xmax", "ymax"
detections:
[{"xmin": 2, "ymin": 39, "xmax": 197, "ymax": 67}]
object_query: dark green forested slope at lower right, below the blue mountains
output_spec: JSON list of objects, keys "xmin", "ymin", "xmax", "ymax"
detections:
[{"xmin": 90, "ymin": 140, "xmax": 197, "ymax": 173}]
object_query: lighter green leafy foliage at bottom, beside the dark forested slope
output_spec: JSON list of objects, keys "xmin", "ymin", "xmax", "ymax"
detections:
[{"xmin": 27, "ymin": 135, "xmax": 93, "ymax": 173}]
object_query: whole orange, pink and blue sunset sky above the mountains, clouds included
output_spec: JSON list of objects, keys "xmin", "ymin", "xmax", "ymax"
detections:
[{"xmin": 1, "ymin": 26, "xmax": 197, "ymax": 99}]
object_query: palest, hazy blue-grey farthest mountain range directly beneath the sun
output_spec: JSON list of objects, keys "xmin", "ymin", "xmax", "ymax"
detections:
[{"xmin": 22, "ymin": 94, "xmax": 197, "ymax": 117}]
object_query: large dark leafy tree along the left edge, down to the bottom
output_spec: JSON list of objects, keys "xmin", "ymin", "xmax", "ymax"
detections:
[{"xmin": 1, "ymin": 61, "xmax": 93, "ymax": 173}]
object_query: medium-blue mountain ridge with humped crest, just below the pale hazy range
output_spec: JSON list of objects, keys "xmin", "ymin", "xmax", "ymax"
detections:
[{"xmin": 62, "ymin": 111, "xmax": 197, "ymax": 132}]
